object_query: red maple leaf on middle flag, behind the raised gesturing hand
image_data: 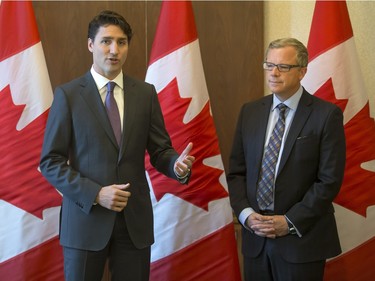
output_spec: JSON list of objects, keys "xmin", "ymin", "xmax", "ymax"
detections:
[{"xmin": 146, "ymin": 79, "xmax": 228, "ymax": 210}]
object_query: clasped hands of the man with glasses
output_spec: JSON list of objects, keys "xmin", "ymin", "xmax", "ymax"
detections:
[{"xmin": 246, "ymin": 213, "xmax": 289, "ymax": 239}]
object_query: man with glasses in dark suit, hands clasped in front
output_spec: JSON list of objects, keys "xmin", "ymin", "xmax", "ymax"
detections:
[{"xmin": 227, "ymin": 38, "xmax": 345, "ymax": 281}]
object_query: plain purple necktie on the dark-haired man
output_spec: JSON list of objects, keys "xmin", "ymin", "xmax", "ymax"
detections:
[{"xmin": 105, "ymin": 81, "xmax": 121, "ymax": 145}]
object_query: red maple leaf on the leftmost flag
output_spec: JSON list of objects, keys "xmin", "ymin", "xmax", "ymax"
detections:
[{"xmin": 0, "ymin": 85, "xmax": 61, "ymax": 219}]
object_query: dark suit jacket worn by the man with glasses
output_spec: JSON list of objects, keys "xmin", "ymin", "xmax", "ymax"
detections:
[{"xmin": 228, "ymin": 90, "xmax": 346, "ymax": 263}]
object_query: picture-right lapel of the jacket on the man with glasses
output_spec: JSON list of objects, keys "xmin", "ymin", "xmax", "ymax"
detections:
[{"xmin": 277, "ymin": 90, "xmax": 312, "ymax": 174}]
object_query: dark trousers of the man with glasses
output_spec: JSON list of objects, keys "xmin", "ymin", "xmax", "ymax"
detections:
[{"xmin": 244, "ymin": 236, "xmax": 326, "ymax": 281}]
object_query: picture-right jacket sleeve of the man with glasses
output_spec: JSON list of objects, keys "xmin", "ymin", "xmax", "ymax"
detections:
[{"xmin": 286, "ymin": 106, "xmax": 346, "ymax": 235}]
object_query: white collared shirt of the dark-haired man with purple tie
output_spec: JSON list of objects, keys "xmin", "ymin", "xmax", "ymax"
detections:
[{"xmin": 90, "ymin": 67, "xmax": 125, "ymax": 130}]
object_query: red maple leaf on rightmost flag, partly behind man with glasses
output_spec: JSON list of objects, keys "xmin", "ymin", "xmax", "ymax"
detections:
[{"xmin": 315, "ymin": 76, "xmax": 375, "ymax": 214}]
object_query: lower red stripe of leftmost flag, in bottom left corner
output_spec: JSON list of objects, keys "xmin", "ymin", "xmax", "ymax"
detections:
[{"xmin": 0, "ymin": 237, "xmax": 64, "ymax": 281}]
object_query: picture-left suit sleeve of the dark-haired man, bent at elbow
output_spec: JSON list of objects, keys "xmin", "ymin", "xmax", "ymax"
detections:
[{"xmin": 40, "ymin": 88, "xmax": 101, "ymax": 213}]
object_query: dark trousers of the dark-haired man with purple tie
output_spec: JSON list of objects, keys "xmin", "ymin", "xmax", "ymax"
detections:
[{"xmin": 64, "ymin": 212, "xmax": 151, "ymax": 281}]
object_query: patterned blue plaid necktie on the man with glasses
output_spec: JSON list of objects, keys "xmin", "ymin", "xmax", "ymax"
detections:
[{"xmin": 257, "ymin": 103, "xmax": 288, "ymax": 210}]
